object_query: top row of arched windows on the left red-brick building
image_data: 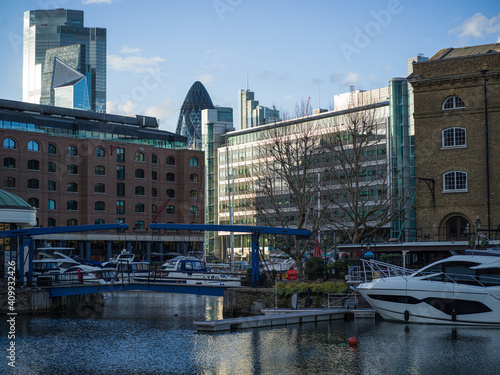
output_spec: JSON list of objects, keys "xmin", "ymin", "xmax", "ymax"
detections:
[{"xmin": 3, "ymin": 138, "xmax": 199, "ymax": 167}]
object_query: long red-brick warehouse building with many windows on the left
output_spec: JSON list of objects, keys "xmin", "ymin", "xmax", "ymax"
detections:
[{"xmin": 0, "ymin": 100, "xmax": 204, "ymax": 260}]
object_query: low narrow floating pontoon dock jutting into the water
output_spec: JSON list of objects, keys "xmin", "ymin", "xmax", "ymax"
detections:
[{"xmin": 194, "ymin": 309, "xmax": 375, "ymax": 332}]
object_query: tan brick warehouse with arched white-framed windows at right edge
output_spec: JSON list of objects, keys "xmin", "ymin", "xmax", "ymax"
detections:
[{"xmin": 409, "ymin": 43, "xmax": 500, "ymax": 241}]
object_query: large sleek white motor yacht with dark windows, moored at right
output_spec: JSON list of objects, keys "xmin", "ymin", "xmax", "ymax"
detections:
[{"xmin": 356, "ymin": 249, "xmax": 500, "ymax": 327}]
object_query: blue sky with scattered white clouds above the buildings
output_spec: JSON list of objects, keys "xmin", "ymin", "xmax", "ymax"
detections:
[{"xmin": 0, "ymin": 0, "xmax": 500, "ymax": 132}]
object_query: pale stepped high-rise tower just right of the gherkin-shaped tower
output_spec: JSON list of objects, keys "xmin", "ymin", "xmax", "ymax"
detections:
[{"xmin": 240, "ymin": 89, "xmax": 280, "ymax": 130}]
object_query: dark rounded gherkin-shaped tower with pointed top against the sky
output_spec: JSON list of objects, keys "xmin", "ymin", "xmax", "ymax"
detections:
[{"xmin": 176, "ymin": 81, "xmax": 215, "ymax": 149}]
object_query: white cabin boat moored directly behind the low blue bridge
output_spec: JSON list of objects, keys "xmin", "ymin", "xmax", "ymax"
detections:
[{"xmin": 139, "ymin": 257, "xmax": 241, "ymax": 286}]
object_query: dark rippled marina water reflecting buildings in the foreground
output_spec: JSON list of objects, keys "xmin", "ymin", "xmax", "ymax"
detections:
[{"xmin": 0, "ymin": 292, "xmax": 500, "ymax": 375}]
